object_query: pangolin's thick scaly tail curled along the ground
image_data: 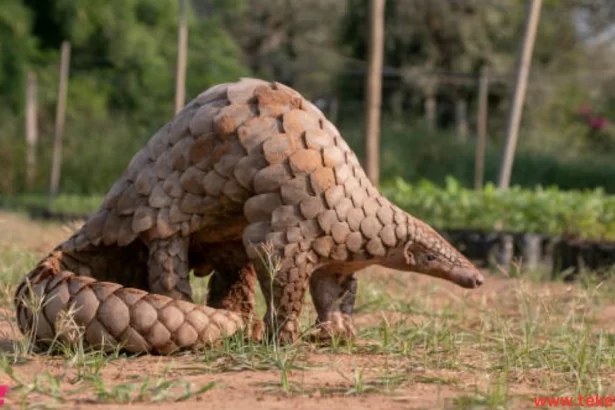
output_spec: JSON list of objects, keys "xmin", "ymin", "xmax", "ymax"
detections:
[{"xmin": 15, "ymin": 242, "xmax": 243, "ymax": 354}]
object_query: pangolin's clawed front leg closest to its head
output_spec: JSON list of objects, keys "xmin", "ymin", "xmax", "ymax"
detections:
[{"xmin": 310, "ymin": 270, "xmax": 358, "ymax": 341}]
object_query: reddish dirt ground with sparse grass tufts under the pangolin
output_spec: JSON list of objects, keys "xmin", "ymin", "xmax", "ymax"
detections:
[{"xmin": 0, "ymin": 212, "xmax": 615, "ymax": 410}]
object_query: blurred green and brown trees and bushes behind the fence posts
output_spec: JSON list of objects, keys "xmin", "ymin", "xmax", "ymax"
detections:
[{"xmin": 0, "ymin": 0, "xmax": 615, "ymax": 196}]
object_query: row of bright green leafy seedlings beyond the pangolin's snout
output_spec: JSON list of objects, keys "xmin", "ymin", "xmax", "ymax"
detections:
[{"xmin": 383, "ymin": 177, "xmax": 615, "ymax": 241}]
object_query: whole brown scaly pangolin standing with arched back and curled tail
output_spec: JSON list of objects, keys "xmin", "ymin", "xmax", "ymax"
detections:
[{"xmin": 15, "ymin": 78, "xmax": 483, "ymax": 354}]
